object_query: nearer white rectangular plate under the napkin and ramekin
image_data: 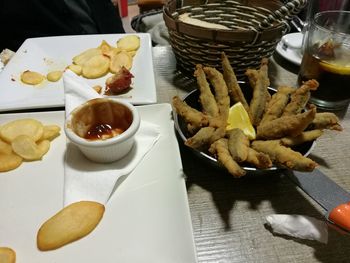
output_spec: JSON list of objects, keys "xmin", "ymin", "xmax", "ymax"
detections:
[{"xmin": 0, "ymin": 104, "xmax": 197, "ymax": 263}]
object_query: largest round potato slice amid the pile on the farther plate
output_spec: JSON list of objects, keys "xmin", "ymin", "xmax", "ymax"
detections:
[{"xmin": 82, "ymin": 55, "xmax": 110, "ymax": 79}]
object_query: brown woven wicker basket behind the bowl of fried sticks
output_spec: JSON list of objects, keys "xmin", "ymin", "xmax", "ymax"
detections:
[{"xmin": 163, "ymin": 0, "xmax": 306, "ymax": 78}]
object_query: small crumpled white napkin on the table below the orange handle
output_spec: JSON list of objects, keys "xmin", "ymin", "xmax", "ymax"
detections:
[{"xmin": 266, "ymin": 215, "xmax": 328, "ymax": 244}]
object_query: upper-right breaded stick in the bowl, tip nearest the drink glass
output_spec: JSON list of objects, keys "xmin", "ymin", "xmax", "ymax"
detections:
[{"xmin": 282, "ymin": 79, "xmax": 319, "ymax": 116}]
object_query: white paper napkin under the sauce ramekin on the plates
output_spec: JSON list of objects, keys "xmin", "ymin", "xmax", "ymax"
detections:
[{"xmin": 63, "ymin": 70, "xmax": 160, "ymax": 206}]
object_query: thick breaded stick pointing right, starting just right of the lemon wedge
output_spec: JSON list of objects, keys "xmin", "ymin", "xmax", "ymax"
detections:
[{"xmin": 257, "ymin": 106, "xmax": 316, "ymax": 140}]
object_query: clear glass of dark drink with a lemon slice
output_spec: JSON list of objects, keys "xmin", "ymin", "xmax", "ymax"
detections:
[{"xmin": 298, "ymin": 11, "xmax": 350, "ymax": 110}]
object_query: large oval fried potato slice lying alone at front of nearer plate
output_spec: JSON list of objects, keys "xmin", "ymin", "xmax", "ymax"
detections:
[{"xmin": 37, "ymin": 201, "xmax": 105, "ymax": 251}]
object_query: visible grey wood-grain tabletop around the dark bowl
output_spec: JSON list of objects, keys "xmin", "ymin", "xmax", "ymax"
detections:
[{"xmin": 153, "ymin": 47, "xmax": 350, "ymax": 263}]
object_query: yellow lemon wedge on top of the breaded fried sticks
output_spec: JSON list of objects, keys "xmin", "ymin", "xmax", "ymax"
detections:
[{"xmin": 226, "ymin": 102, "xmax": 256, "ymax": 140}]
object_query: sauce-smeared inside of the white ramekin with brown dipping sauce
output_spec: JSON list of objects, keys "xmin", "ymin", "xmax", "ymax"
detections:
[{"xmin": 72, "ymin": 98, "xmax": 133, "ymax": 140}]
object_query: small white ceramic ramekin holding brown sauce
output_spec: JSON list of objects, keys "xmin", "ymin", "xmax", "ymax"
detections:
[{"xmin": 64, "ymin": 98, "xmax": 140, "ymax": 163}]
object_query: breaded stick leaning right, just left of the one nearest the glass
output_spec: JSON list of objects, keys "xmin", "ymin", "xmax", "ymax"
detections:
[{"xmin": 260, "ymin": 86, "xmax": 295, "ymax": 125}]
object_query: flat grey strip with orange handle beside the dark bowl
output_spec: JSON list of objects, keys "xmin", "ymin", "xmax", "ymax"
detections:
[{"xmin": 285, "ymin": 169, "xmax": 350, "ymax": 234}]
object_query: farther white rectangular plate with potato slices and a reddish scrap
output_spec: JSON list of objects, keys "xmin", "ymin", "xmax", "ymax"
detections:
[{"xmin": 0, "ymin": 34, "xmax": 157, "ymax": 111}]
